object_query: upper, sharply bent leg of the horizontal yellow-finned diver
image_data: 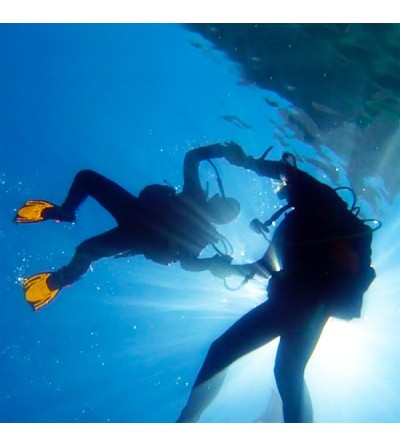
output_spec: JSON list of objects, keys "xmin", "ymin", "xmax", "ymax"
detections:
[{"xmin": 45, "ymin": 169, "xmax": 137, "ymax": 223}]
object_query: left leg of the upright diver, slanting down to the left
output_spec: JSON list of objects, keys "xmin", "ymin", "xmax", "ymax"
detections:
[{"xmin": 177, "ymin": 302, "xmax": 281, "ymax": 422}]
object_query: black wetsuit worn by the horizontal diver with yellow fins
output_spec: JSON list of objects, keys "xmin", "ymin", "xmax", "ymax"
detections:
[{"xmin": 48, "ymin": 144, "xmax": 226, "ymax": 289}]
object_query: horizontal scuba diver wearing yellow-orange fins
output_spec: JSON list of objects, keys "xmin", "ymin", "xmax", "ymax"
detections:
[{"xmin": 15, "ymin": 143, "xmax": 240, "ymax": 310}]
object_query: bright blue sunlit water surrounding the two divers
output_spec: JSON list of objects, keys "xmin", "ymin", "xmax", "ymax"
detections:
[{"xmin": 0, "ymin": 24, "xmax": 400, "ymax": 428}]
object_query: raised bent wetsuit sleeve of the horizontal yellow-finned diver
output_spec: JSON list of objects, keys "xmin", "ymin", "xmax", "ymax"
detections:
[{"xmin": 182, "ymin": 144, "xmax": 233, "ymax": 199}]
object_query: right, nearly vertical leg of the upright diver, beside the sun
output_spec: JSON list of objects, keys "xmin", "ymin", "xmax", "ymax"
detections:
[{"xmin": 274, "ymin": 306, "xmax": 329, "ymax": 422}]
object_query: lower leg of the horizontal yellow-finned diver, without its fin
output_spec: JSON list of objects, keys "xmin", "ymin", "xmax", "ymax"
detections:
[{"xmin": 47, "ymin": 227, "xmax": 139, "ymax": 290}]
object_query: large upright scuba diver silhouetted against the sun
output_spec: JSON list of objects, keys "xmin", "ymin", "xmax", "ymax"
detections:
[{"xmin": 177, "ymin": 143, "xmax": 375, "ymax": 422}]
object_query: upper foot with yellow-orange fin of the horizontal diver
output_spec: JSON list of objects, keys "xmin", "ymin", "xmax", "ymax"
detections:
[{"xmin": 14, "ymin": 200, "xmax": 75, "ymax": 223}]
